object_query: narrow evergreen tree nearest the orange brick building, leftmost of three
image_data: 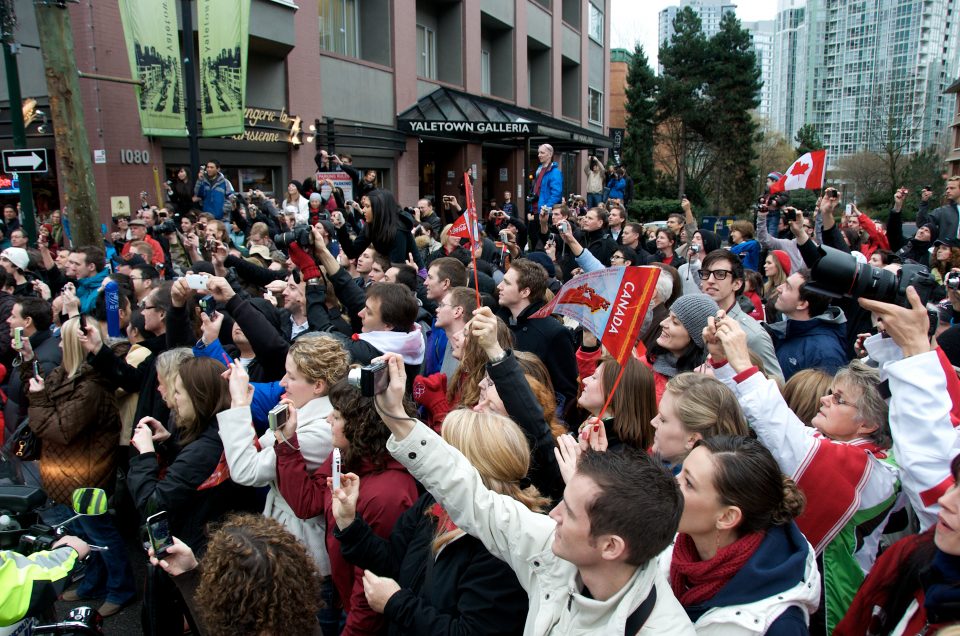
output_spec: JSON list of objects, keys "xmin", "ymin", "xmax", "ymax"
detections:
[{"xmin": 623, "ymin": 44, "xmax": 657, "ymax": 198}]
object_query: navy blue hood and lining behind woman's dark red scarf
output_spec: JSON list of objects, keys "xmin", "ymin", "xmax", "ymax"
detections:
[{"xmin": 684, "ymin": 522, "xmax": 812, "ymax": 636}]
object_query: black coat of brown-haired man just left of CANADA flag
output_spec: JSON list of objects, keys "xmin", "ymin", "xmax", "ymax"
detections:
[{"xmin": 499, "ymin": 301, "xmax": 578, "ymax": 412}]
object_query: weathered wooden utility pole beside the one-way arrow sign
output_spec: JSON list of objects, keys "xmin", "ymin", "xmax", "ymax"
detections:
[{"xmin": 34, "ymin": 0, "xmax": 103, "ymax": 245}]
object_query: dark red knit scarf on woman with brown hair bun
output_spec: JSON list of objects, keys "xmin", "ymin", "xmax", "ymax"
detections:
[{"xmin": 670, "ymin": 532, "xmax": 766, "ymax": 607}]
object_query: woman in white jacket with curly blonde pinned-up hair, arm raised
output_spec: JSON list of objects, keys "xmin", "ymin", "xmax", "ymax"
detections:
[{"xmin": 217, "ymin": 336, "xmax": 349, "ymax": 576}]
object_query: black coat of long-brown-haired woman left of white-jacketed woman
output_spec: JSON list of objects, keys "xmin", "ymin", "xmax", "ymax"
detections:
[{"xmin": 127, "ymin": 420, "xmax": 262, "ymax": 554}]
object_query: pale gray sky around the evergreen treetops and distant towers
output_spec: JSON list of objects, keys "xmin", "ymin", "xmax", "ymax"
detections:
[{"xmin": 610, "ymin": 0, "xmax": 777, "ymax": 68}]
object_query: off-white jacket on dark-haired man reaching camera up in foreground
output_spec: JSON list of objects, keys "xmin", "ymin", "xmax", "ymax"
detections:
[{"xmin": 387, "ymin": 422, "xmax": 694, "ymax": 636}]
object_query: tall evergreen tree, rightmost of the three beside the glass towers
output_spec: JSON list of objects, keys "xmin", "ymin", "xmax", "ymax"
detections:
[{"xmin": 706, "ymin": 12, "xmax": 762, "ymax": 213}]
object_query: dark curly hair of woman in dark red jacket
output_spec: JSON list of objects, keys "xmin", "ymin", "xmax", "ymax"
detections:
[{"xmin": 330, "ymin": 379, "xmax": 417, "ymax": 472}]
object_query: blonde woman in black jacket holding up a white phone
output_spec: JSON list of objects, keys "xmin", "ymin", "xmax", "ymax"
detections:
[{"xmin": 332, "ymin": 409, "xmax": 549, "ymax": 635}]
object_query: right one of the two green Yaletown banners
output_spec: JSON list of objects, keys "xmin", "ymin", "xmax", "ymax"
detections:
[{"xmin": 197, "ymin": 0, "xmax": 250, "ymax": 137}]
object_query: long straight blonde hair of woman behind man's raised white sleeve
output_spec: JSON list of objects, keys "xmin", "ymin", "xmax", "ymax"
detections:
[{"xmin": 427, "ymin": 408, "xmax": 549, "ymax": 554}]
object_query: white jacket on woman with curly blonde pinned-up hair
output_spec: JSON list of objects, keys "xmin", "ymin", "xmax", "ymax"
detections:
[{"xmin": 217, "ymin": 396, "xmax": 333, "ymax": 576}]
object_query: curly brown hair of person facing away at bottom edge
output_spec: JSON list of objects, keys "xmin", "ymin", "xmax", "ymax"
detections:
[{"xmin": 197, "ymin": 514, "xmax": 321, "ymax": 636}]
